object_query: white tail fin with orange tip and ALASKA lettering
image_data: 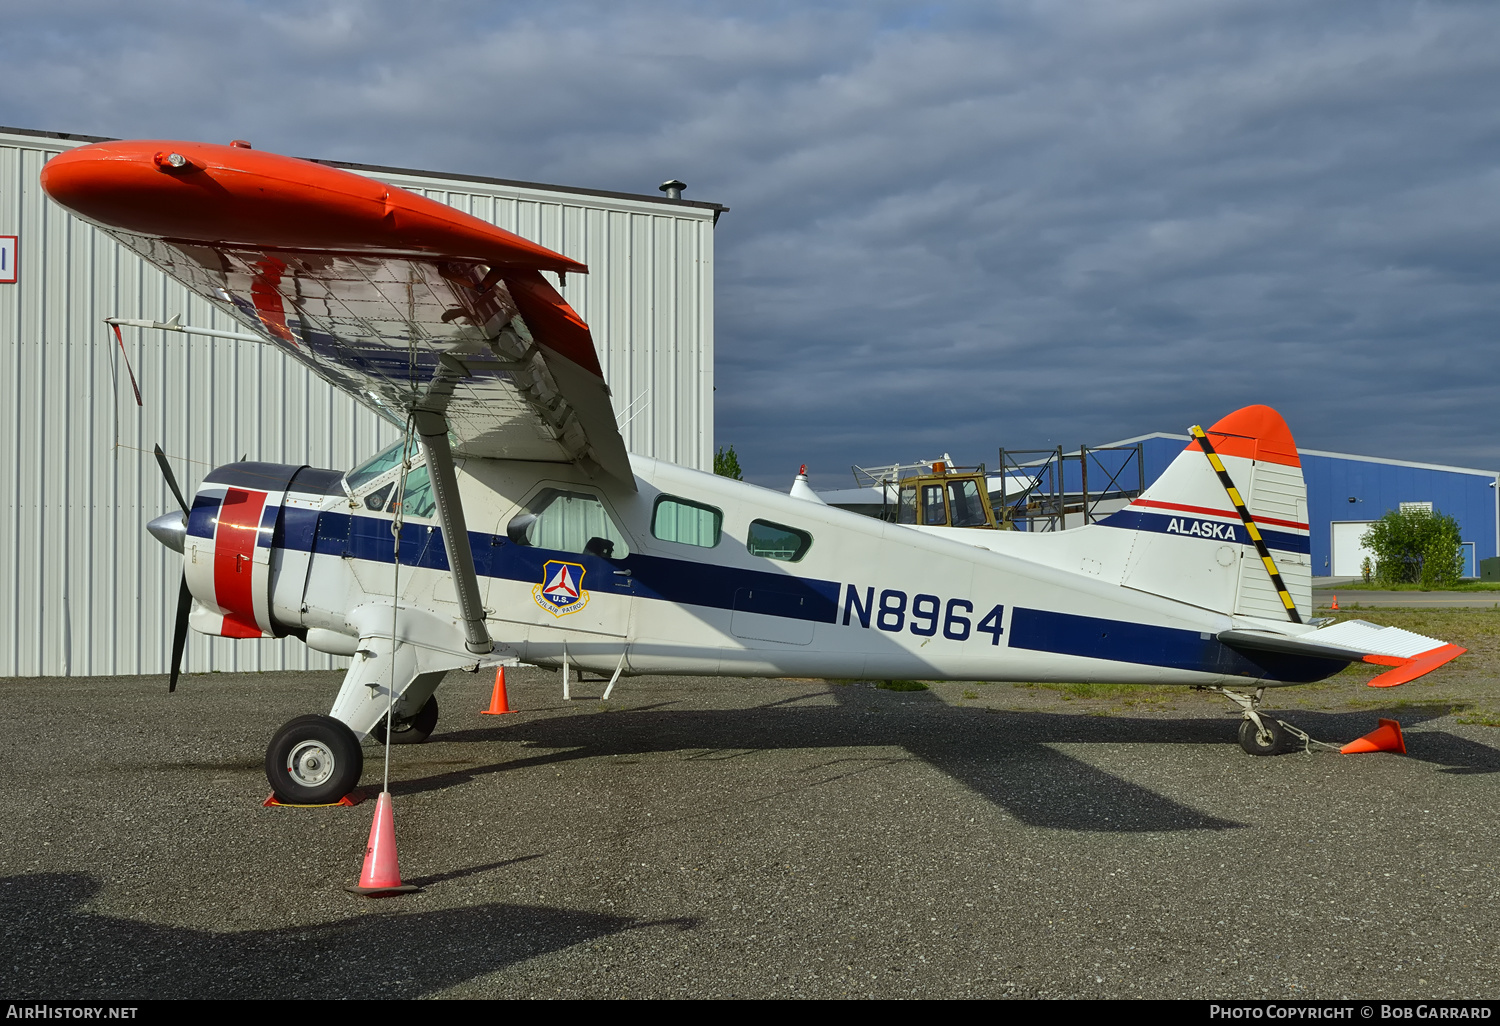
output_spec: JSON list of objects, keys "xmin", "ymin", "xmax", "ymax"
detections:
[{"xmin": 1101, "ymin": 407, "xmax": 1313, "ymax": 621}]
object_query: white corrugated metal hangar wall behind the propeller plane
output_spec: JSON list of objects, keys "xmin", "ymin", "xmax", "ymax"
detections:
[{"xmin": 0, "ymin": 129, "xmax": 723, "ymax": 677}]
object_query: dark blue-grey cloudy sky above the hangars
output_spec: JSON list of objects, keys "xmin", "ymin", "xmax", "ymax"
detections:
[{"xmin": 0, "ymin": 0, "xmax": 1500, "ymax": 488}]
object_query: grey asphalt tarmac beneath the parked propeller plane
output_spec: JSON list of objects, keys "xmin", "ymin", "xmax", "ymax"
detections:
[{"xmin": 0, "ymin": 671, "xmax": 1500, "ymax": 999}]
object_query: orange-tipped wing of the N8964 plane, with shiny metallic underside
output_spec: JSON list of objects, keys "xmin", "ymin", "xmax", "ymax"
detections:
[{"xmin": 42, "ymin": 141, "xmax": 635, "ymax": 488}]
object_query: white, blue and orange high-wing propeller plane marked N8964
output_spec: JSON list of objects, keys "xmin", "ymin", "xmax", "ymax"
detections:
[{"xmin": 42, "ymin": 141, "xmax": 1464, "ymax": 804}]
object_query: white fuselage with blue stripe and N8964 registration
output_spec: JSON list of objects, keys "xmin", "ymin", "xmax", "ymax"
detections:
[{"xmin": 249, "ymin": 458, "xmax": 1326, "ymax": 684}]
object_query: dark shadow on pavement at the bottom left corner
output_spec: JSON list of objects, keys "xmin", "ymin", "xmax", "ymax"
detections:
[{"xmin": 0, "ymin": 873, "xmax": 696, "ymax": 1001}]
